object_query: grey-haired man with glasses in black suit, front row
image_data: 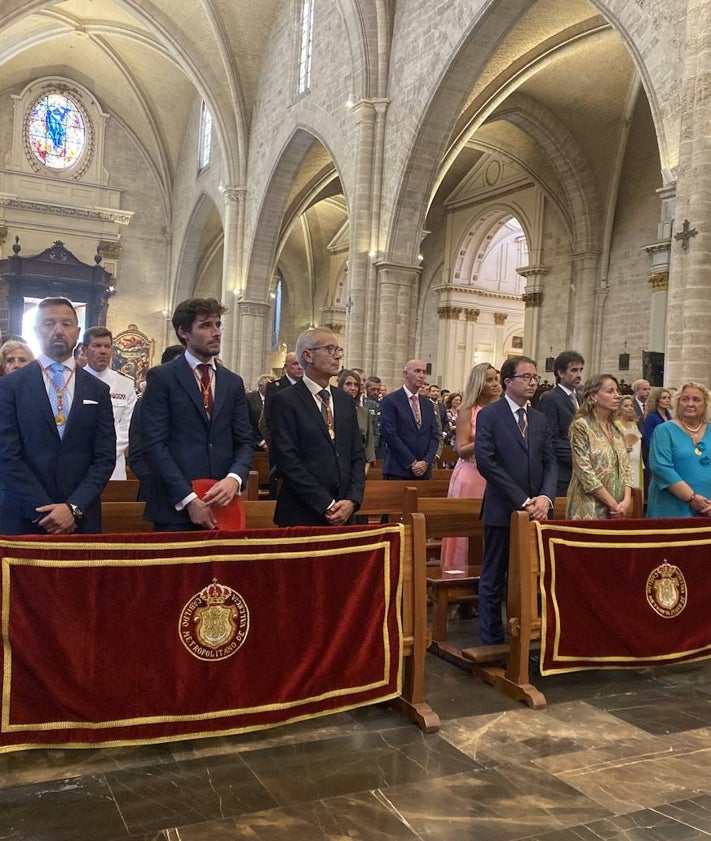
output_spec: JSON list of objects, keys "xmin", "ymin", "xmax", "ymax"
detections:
[{"xmin": 270, "ymin": 327, "xmax": 365, "ymax": 526}]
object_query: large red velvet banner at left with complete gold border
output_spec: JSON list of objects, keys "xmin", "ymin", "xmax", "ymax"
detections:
[{"xmin": 0, "ymin": 526, "xmax": 402, "ymax": 752}]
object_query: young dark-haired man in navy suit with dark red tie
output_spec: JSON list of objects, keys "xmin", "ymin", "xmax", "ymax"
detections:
[{"xmin": 141, "ymin": 298, "xmax": 254, "ymax": 531}]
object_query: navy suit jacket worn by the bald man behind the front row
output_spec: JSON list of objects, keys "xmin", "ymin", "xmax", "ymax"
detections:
[{"xmin": 380, "ymin": 388, "xmax": 440, "ymax": 479}]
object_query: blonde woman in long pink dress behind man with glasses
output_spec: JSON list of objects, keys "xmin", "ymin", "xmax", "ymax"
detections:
[{"xmin": 441, "ymin": 362, "xmax": 501, "ymax": 575}]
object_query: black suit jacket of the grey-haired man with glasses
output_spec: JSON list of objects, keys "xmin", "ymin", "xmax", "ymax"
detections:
[{"xmin": 270, "ymin": 382, "xmax": 365, "ymax": 526}]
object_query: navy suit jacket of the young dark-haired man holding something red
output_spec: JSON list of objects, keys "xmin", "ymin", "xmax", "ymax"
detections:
[{"xmin": 141, "ymin": 355, "xmax": 254, "ymax": 524}]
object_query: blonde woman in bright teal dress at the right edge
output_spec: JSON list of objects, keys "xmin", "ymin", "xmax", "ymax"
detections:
[{"xmin": 647, "ymin": 382, "xmax": 711, "ymax": 517}]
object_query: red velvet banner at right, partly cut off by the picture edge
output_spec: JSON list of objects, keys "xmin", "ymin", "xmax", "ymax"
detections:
[{"xmin": 538, "ymin": 520, "xmax": 711, "ymax": 675}]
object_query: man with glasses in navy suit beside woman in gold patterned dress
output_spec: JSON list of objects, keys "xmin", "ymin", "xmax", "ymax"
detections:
[{"xmin": 474, "ymin": 356, "xmax": 557, "ymax": 645}]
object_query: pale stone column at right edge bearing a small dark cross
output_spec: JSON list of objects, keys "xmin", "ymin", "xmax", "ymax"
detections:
[{"xmin": 662, "ymin": 0, "xmax": 711, "ymax": 386}]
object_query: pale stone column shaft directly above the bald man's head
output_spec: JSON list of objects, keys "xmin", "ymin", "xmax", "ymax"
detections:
[{"xmin": 376, "ymin": 263, "xmax": 421, "ymax": 390}]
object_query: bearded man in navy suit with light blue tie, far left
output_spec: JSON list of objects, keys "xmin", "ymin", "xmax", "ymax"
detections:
[{"xmin": 0, "ymin": 298, "xmax": 116, "ymax": 534}]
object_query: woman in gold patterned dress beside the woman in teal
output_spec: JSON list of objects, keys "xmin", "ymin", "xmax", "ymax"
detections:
[{"xmin": 566, "ymin": 374, "xmax": 633, "ymax": 520}]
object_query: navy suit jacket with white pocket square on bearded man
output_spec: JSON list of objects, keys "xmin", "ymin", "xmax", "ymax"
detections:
[{"xmin": 0, "ymin": 361, "xmax": 116, "ymax": 534}]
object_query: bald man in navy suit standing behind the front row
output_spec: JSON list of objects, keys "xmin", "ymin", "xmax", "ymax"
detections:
[{"xmin": 380, "ymin": 359, "xmax": 441, "ymax": 479}]
